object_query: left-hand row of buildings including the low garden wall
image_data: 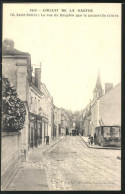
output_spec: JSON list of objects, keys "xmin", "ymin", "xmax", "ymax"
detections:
[{"xmin": 1, "ymin": 39, "xmax": 68, "ymax": 188}]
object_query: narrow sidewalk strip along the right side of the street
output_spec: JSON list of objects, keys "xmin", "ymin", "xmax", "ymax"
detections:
[{"xmin": 81, "ymin": 136, "xmax": 121, "ymax": 150}]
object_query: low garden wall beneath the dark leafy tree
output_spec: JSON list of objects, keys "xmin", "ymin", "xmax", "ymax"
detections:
[{"xmin": 1, "ymin": 132, "xmax": 21, "ymax": 190}]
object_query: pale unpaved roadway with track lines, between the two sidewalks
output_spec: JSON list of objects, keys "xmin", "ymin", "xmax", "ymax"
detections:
[{"xmin": 44, "ymin": 136, "xmax": 121, "ymax": 190}]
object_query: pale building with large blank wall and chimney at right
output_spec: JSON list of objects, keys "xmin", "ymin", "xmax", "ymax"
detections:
[{"xmin": 91, "ymin": 71, "xmax": 121, "ymax": 137}]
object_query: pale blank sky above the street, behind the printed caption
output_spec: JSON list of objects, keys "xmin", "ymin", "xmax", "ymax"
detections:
[{"xmin": 3, "ymin": 3, "xmax": 121, "ymax": 111}]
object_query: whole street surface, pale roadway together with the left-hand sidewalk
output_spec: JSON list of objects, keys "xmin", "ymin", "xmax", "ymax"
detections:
[{"xmin": 6, "ymin": 136, "xmax": 121, "ymax": 191}]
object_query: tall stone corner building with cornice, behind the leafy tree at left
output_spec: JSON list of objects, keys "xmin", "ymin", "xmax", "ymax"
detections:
[{"xmin": 2, "ymin": 39, "xmax": 31, "ymax": 160}]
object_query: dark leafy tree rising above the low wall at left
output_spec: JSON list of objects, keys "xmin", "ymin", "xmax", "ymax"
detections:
[{"xmin": 2, "ymin": 76, "xmax": 26, "ymax": 132}]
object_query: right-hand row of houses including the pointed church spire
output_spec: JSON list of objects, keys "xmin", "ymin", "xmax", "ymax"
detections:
[{"xmin": 81, "ymin": 70, "xmax": 121, "ymax": 138}]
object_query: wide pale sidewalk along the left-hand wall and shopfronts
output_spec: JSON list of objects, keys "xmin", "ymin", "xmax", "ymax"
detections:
[{"xmin": 6, "ymin": 136, "xmax": 65, "ymax": 191}]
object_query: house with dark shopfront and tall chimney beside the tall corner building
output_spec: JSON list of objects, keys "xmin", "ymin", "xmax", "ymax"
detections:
[{"xmin": 28, "ymin": 68, "xmax": 44, "ymax": 149}]
